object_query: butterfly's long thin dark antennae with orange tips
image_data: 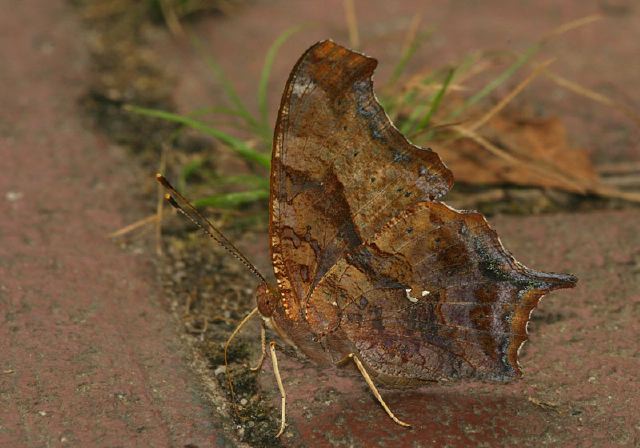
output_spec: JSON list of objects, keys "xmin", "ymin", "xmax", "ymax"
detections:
[{"xmin": 156, "ymin": 173, "xmax": 267, "ymax": 283}]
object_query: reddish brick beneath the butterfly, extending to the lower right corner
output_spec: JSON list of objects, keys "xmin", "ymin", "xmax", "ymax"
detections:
[{"xmin": 261, "ymin": 211, "xmax": 640, "ymax": 447}]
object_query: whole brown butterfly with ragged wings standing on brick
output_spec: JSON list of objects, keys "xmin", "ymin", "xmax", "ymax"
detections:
[{"xmin": 158, "ymin": 40, "xmax": 577, "ymax": 435}]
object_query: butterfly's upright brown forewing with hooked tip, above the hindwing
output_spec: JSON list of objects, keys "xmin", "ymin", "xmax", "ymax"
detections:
[{"xmin": 270, "ymin": 41, "xmax": 453, "ymax": 319}]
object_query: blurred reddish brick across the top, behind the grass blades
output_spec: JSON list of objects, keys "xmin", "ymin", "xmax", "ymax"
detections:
[{"xmin": 169, "ymin": 0, "xmax": 640, "ymax": 163}]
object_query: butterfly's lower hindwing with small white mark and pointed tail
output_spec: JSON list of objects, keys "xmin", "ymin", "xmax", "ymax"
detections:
[{"xmin": 307, "ymin": 202, "xmax": 576, "ymax": 387}]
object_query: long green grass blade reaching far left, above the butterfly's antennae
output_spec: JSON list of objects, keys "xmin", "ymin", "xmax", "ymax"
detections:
[{"xmin": 124, "ymin": 105, "xmax": 271, "ymax": 168}]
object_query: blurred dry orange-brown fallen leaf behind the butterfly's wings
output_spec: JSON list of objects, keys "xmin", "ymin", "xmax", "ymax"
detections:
[{"xmin": 434, "ymin": 113, "xmax": 600, "ymax": 193}]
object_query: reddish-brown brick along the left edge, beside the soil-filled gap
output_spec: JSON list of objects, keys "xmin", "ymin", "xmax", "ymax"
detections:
[{"xmin": 0, "ymin": 1, "xmax": 238, "ymax": 447}]
